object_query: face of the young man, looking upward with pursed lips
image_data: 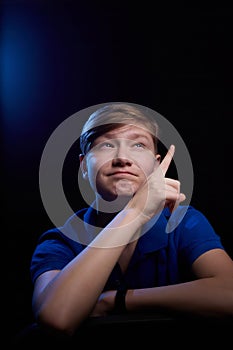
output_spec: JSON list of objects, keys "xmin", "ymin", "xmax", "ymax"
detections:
[{"xmin": 80, "ymin": 125, "xmax": 160, "ymax": 201}]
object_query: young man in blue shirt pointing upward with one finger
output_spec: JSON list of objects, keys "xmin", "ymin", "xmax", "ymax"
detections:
[{"xmin": 31, "ymin": 103, "xmax": 233, "ymax": 335}]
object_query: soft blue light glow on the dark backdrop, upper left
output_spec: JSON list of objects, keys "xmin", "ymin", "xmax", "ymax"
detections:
[{"xmin": 1, "ymin": 5, "xmax": 44, "ymax": 126}]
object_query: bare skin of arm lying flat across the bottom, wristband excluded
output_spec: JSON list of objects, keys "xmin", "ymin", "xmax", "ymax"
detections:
[{"xmin": 91, "ymin": 249, "xmax": 233, "ymax": 317}]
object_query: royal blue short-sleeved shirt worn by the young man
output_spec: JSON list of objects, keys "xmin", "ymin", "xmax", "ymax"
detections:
[{"xmin": 30, "ymin": 206, "xmax": 224, "ymax": 290}]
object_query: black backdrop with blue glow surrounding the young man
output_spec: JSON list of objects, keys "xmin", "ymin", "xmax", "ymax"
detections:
[{"xmin": 1, "ymin": 1, "xmax": 233, "ymax": 340}]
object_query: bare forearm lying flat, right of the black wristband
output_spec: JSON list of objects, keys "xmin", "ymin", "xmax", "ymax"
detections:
[{"xmin": 126, "ymin": 278, "xmax": 233, "ymax": 316}]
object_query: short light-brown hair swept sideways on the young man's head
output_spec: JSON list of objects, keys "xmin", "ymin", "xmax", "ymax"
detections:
[{"xmin": 80, "ymin": 102, "xmax": 158, "ymax": 154}]
